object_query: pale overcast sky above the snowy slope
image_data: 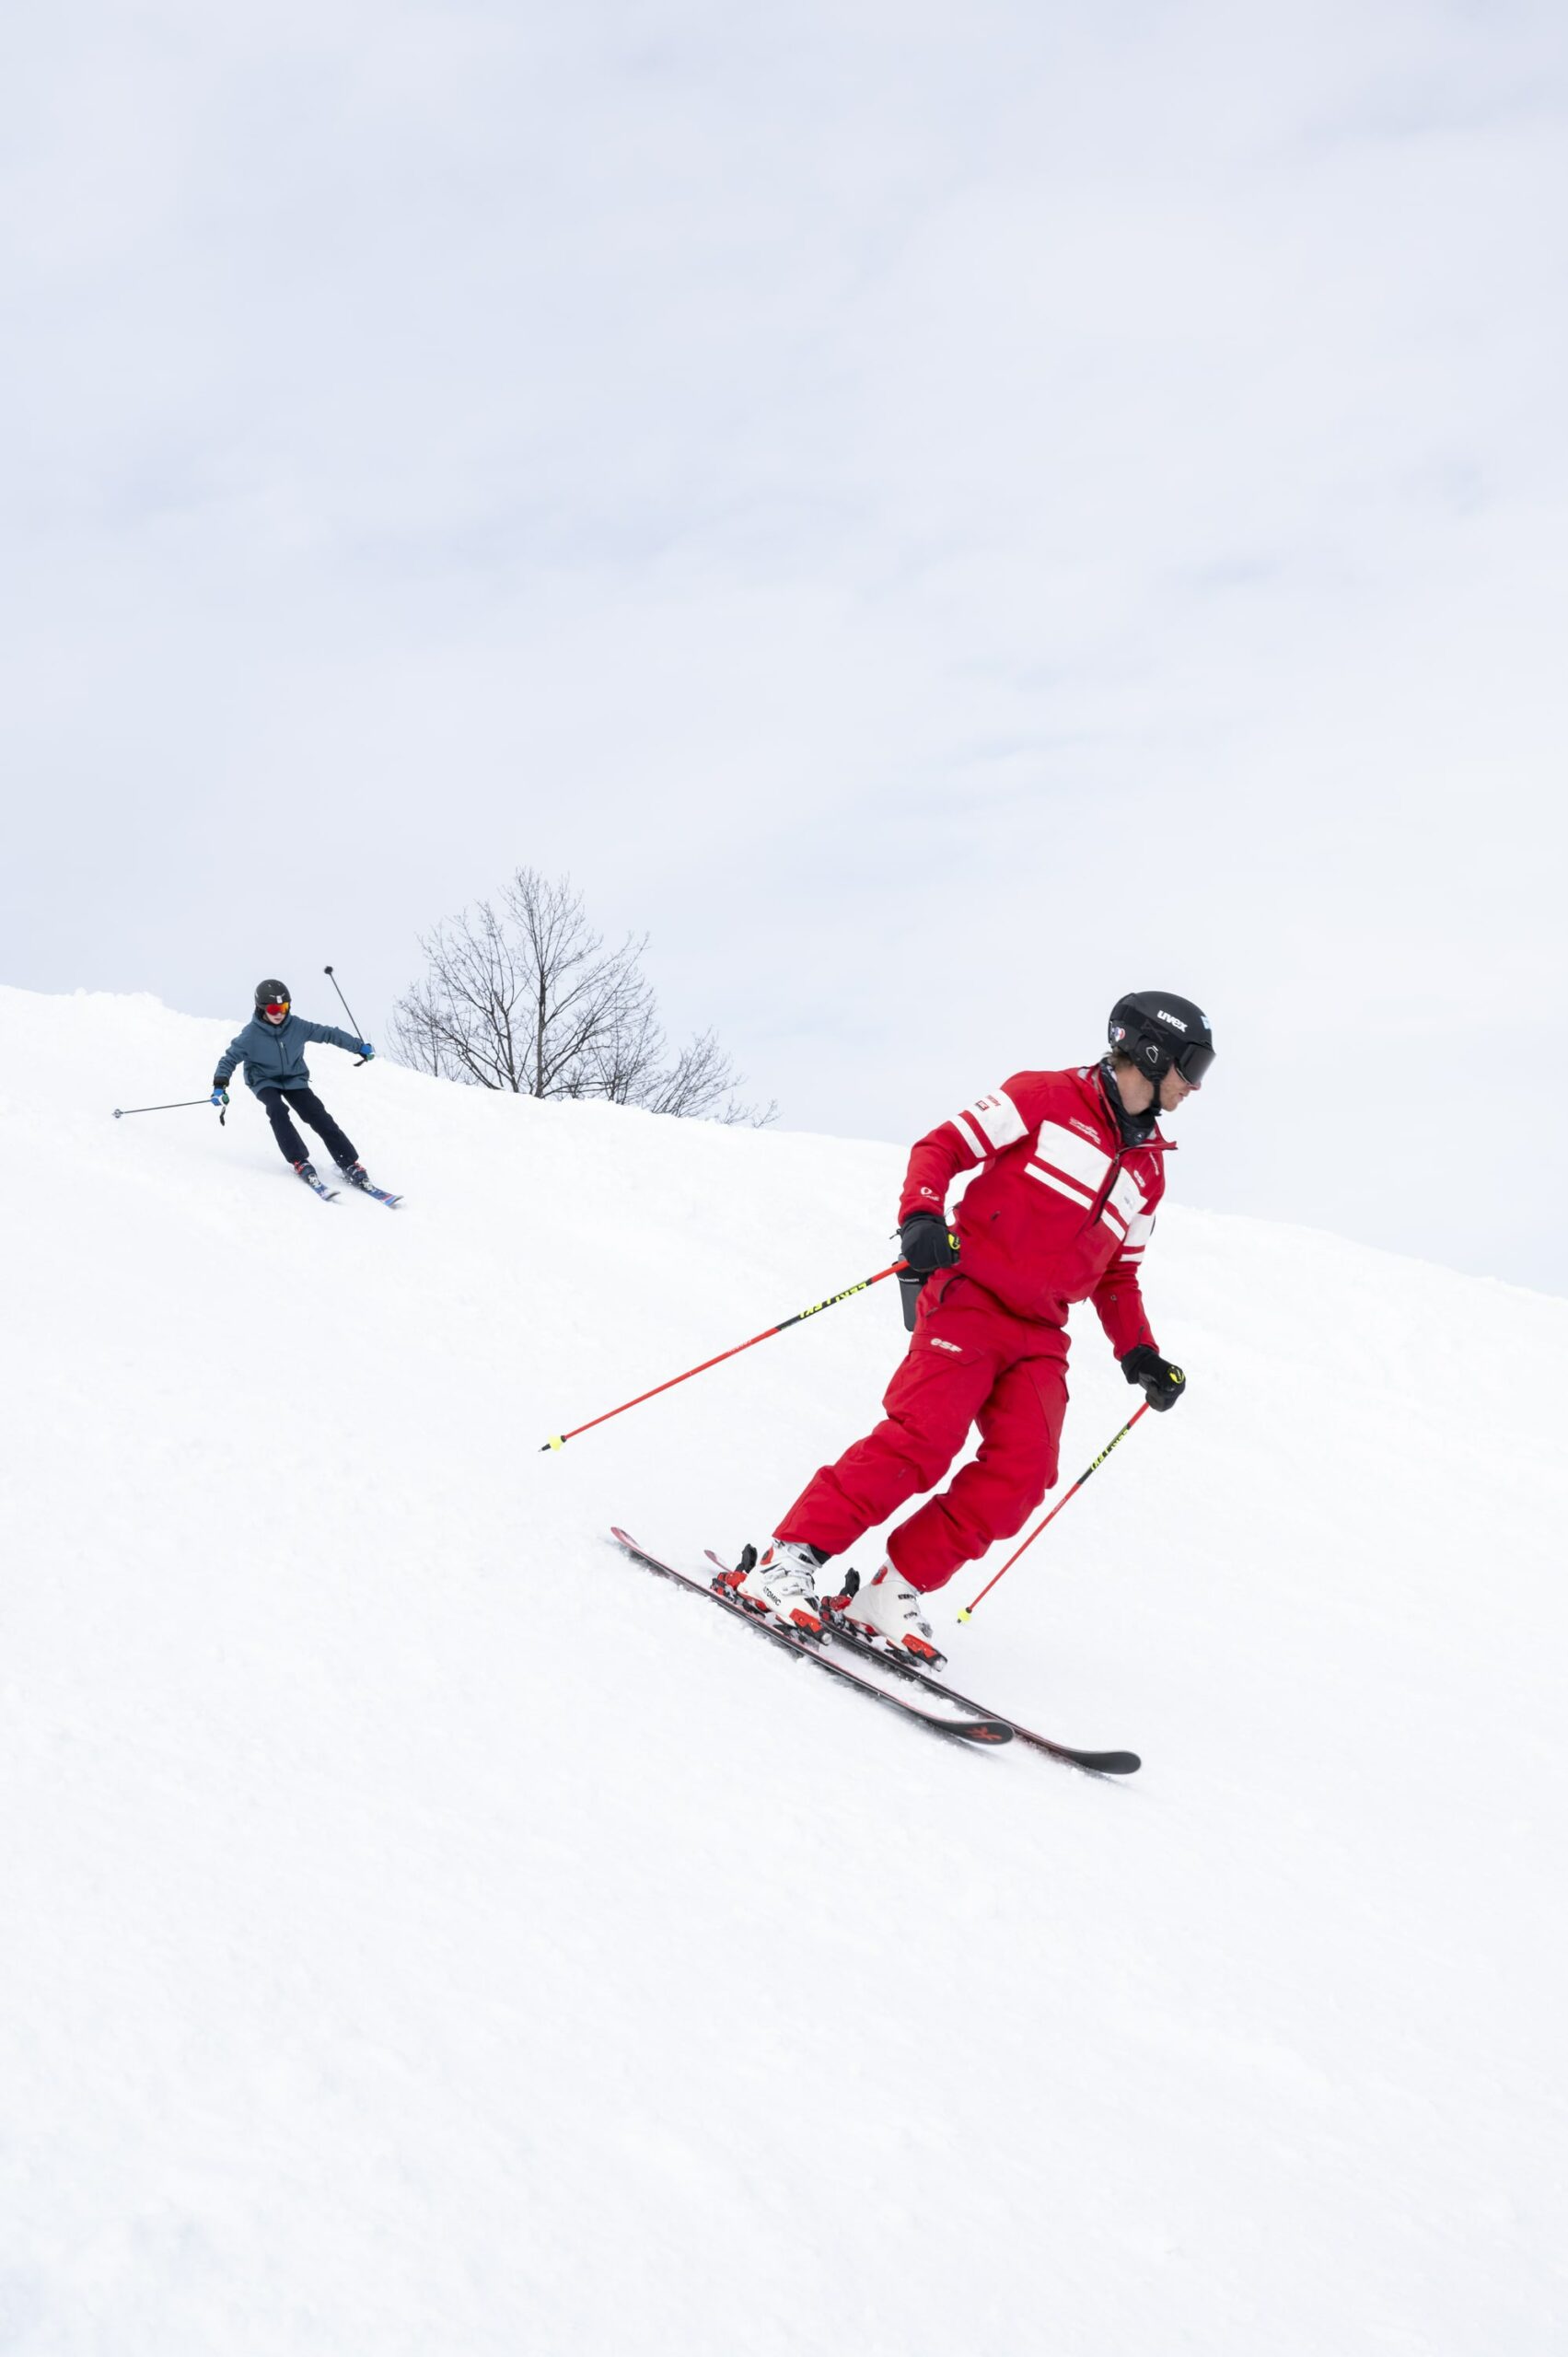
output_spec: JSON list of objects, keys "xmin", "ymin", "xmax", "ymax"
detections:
[{"xmin": 0, "ymin": 0, "xmax": 1568, "ymax": 1289}]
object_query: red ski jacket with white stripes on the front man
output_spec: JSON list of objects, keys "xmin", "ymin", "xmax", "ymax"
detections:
[{"xmin": 899, "ymin": 1063, "xmax": 1172, "ymax": 1358}]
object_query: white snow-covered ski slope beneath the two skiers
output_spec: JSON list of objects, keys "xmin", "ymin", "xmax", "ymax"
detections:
[{"xmin": 0, "ymin": 990, "xmax": 1568, "ymax": 2357}]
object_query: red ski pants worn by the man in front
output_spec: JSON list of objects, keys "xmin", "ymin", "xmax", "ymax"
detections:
[{"xmin": 776, "ymin": 1268, "xmax": 1068, "ymax": 1591}]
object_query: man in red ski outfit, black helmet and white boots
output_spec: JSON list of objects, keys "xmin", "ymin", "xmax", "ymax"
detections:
[{"xmin": 722, "ymin": 990, "xmax": 1214, "ymax": 1666}]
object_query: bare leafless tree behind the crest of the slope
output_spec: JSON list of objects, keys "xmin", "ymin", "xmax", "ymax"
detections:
[{"xmin": 391, "ymin": 867, "xmax": 778, "ymax": 1127}]
